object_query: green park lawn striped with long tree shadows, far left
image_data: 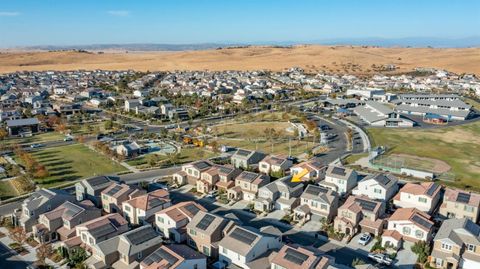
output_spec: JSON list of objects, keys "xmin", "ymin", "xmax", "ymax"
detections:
[{"xmin": 17, "ymin": 144, "xmax": 126, "ymax": 187}]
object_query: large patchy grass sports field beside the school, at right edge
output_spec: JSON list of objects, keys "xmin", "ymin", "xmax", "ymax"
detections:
[{"xmin": 368, "ymin": 121, "xmax": 480, "ymax": 190}]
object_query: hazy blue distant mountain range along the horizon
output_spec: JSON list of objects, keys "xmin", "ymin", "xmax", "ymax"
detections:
[{"xmin": 21, "ymin": 36, "xmax": 480, "ymax": 51}]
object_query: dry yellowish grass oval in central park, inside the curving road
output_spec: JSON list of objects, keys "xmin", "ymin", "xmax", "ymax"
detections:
[{"xmin": 212, "ymin": 121, "xmax": 319, "ymax": 156}]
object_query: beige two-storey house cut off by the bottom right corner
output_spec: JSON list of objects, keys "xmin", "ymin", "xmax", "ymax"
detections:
[{"xmin": 429, "ymin": 218, "xmax": 480, "ymax": 269}]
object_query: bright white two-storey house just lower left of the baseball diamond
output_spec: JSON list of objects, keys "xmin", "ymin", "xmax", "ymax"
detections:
[{"xmin": 352, "ymin": 174, "xmax": 398, "ymax": 201}]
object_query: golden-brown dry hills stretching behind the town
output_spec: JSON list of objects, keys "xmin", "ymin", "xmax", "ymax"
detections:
[{"xmin": 0, "ymin": 45, "xmax": 480, "ymax": 75}]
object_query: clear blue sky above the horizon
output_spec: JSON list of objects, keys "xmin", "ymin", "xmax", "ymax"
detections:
[{"xmin": 0, "ymin": 0, "xmax": 480, "ymax": 47}]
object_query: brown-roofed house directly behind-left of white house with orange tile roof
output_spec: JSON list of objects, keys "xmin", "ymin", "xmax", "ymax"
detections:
[{"xmin": 101, "ymin": 183, "xmax": 146, "ymax": 213}]
